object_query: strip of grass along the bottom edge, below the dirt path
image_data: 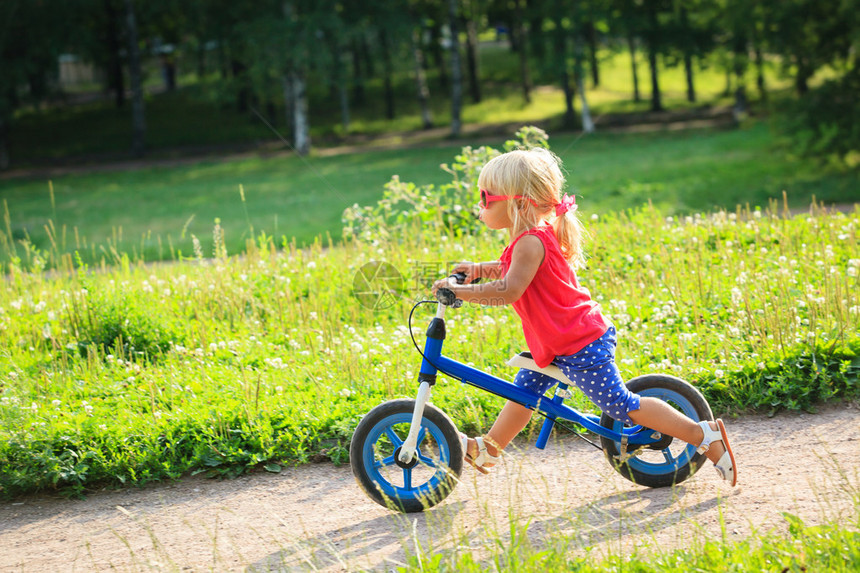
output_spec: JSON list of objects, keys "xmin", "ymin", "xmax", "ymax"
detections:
[{"xmin": 398, "ymin": 508, "xmax": 860, "ymax": 573}]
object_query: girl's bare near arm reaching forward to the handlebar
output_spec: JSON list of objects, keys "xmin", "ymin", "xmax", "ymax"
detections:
[{"xmin": 433, "ymin": 235, "xmax": 544, "ymax": 306}]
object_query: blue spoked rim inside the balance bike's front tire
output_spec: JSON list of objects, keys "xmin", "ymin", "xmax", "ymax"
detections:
[{"xmin": 361, "ymin": 412, "xmax": 451, "ymax": 501}]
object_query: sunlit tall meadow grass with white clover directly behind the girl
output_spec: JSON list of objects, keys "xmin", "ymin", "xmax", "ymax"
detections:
[{"xmin": 0, "ymin": 127, "xmax": 860, "ymax": 497}]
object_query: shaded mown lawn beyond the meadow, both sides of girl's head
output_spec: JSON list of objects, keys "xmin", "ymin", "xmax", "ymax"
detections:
[{"xmin": 0, "ymin": 124, "xmax": 860, "ymax": 263}]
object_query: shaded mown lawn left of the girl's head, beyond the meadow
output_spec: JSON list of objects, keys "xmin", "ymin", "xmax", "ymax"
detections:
[{"xmin": 0, "ymin": 143, "xmax": 464, "ymax": 261}]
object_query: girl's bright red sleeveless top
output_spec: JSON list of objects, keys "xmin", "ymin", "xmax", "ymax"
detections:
[{"xmin": 499, "ymin": 226, "xmax": 610, "ymax": 368}]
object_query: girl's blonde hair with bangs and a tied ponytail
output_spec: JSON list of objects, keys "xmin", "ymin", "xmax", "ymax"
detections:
[{"xmin": 478, "ymin": 147, "xmax": 586, "ymax": 268}]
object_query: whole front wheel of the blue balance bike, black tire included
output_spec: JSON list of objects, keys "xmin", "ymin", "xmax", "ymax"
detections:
[{"xmin": 349, "ymin": 399, "xmax": 463, "ymax": 513}]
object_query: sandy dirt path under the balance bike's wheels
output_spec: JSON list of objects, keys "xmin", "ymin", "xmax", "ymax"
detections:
[{"xmin": 0, "ymin": 404, "xmax": 860, "ymax": 572}]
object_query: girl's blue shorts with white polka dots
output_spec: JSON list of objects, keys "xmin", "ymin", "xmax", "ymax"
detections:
[{"xmin": 514, "ymin": 326, "xmax": 639, "ymax": 425}]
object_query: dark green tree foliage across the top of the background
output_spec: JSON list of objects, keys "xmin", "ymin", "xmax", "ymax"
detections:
[{"xmin": 0, "ymin": 0, "xmax": 860, "ymax": 167}]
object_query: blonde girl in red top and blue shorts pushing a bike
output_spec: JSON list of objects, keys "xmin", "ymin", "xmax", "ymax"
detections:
[{"xmin": 433, "ymin": 149, "xmax": 737, "ymax": 486}]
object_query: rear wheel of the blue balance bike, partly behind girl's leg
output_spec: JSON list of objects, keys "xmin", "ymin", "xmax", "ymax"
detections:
[{"xmin": 600, "ymin": 374, "xmax": 714, "ymax": 487}]
